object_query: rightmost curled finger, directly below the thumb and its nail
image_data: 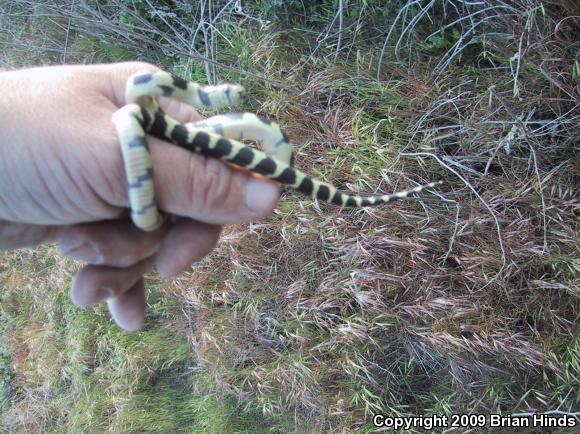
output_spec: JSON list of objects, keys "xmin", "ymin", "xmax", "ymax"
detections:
[{"xmin": 156, "ymin": 219, "xmax": 221, "ymax": 277}]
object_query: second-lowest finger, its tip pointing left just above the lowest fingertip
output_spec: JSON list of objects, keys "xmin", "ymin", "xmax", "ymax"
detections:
[{"xmin": 70, "ymin": 258, "xmax": 153, "ymax": 307}]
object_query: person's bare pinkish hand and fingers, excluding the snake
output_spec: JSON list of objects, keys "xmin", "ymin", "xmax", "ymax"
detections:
[{"xmin": 0, "ymin": 62, "xmax": 279, "ymax": 330}]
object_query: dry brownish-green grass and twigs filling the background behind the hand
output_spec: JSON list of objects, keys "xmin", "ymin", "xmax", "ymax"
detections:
[{"xmin": 0, "ymin": 0, "xmax": 580, "ymax": 433}]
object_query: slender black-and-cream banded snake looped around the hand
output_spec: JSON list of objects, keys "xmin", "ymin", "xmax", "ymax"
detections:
[{"xmin": 113, "ymin": 71, "xmax": 440, "ymax": 231}]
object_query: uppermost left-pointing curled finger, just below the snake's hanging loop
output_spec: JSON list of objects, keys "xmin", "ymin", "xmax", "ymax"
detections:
[{"xmin": 59, "ymin": 220, "xmax": 167, "ymax": 267}]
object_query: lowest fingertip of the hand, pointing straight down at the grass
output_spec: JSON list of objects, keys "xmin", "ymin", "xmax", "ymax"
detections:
[{"xmin": 107, "ymin": 279, "xmax": 145, "ymax": 331}]
